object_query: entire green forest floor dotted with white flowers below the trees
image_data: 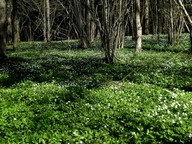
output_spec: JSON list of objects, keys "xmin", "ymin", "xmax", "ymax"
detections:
[{"xmin": 0, "ymin": 35, "xmax": 192, "ymax": 144}]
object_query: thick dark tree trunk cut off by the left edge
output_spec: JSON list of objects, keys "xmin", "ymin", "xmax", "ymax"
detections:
[{"xmin": 0, "ymin": 0, "xmax": 7, "ymax": 58}]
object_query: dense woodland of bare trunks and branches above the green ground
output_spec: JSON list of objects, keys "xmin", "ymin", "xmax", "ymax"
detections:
[{"xmin": 0, "ymin": 0, "xmax": 192, "ymax": 63}]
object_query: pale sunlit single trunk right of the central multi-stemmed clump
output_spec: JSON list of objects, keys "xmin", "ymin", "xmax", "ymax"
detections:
[{"xmin": 135, "ymin": 0, "xmax": 142, "ymax": 53}]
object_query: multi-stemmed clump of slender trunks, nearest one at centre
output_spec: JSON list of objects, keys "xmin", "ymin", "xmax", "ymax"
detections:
[{"xmin": 98, "ymin": 0, "xmax": 126, "ymax": 63}]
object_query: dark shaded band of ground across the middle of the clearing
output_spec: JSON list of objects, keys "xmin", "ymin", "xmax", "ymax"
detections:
[{"xmin": 0, "ymin": 51, "xmax": 192, "ymax": 91}]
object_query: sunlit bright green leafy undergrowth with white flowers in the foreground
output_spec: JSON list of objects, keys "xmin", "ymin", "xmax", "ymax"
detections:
[{"xmin": 0, "ymin": 81, "xmax": 192, "ymax": 143}]
